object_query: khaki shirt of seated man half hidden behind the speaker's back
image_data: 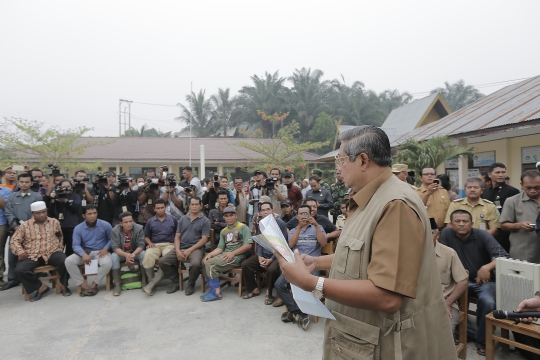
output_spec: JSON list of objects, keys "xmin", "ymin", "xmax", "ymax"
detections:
[{"xmin": 435, "ymin": 241, "xmax": 469, "ymax": 310}]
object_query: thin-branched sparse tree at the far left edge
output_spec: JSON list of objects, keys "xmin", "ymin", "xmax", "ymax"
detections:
[{"xmin": 0, "ymin": 118, "xmax": 105, "ymax": 171}]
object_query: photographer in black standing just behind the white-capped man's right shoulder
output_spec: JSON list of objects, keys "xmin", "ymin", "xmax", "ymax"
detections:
[{"xmin": 47, "ymin": 180, "xmax": 81, "ymax": 256}]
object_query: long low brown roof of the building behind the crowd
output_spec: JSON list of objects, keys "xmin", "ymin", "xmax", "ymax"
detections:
[{"xmin": 56, "ymin": 137, "xmax": 319, "ymax": 162}]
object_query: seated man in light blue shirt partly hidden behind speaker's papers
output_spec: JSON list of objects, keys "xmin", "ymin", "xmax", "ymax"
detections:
[{"xmin": 275, "ymin": 204, "xmax": 327, "ymax": 330}]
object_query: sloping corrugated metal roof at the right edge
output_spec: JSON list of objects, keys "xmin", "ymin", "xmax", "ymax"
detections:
[{"xmin": 391, "ymin": 75, "xmax": 540, "ymax": 146}]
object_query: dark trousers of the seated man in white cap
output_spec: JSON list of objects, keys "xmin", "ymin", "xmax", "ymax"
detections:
[{"xmin": 15, "ymin": 251, "xmax": 67, "ymax": 294}]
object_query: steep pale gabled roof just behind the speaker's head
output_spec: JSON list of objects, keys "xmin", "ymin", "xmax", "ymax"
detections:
[{"xmin": 381, "ymin": 93, "xmax": 451, "ymax": 142}]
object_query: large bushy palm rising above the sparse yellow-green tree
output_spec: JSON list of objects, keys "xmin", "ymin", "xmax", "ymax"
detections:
[{"xmin": 238, "ymin": 71, "xmax": 287, "ymax": 137}]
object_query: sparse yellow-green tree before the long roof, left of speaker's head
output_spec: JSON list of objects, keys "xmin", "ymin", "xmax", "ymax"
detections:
[{"xmin": 231, "ymin": 121, "xmax": 328, "ymax": 175}]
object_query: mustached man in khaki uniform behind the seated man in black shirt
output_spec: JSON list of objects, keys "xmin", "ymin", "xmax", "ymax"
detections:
[{"xmin": 444, "ymin": 178, "xmax": 500, "ymax": 236}]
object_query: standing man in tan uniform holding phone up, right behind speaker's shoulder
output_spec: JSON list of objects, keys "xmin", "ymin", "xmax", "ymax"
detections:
[{"xmin": 416, "ymin": 168, "xmax": 450, "ymax": 231}]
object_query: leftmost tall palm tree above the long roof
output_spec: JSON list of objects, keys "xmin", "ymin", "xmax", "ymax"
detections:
[{"xmin": 174, "ymin": 90, "xmax": 218, "ymax": 137}]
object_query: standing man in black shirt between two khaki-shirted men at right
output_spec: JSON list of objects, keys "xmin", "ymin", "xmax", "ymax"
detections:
[{"xmin": 482, "ymin": 163, "xmax": 519, "ymax": 253}]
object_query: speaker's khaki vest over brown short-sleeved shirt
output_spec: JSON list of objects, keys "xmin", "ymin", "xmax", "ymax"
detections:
[{"xmin": 323, "ymin": 168, "xmax": 456, "ymax": 360}]
